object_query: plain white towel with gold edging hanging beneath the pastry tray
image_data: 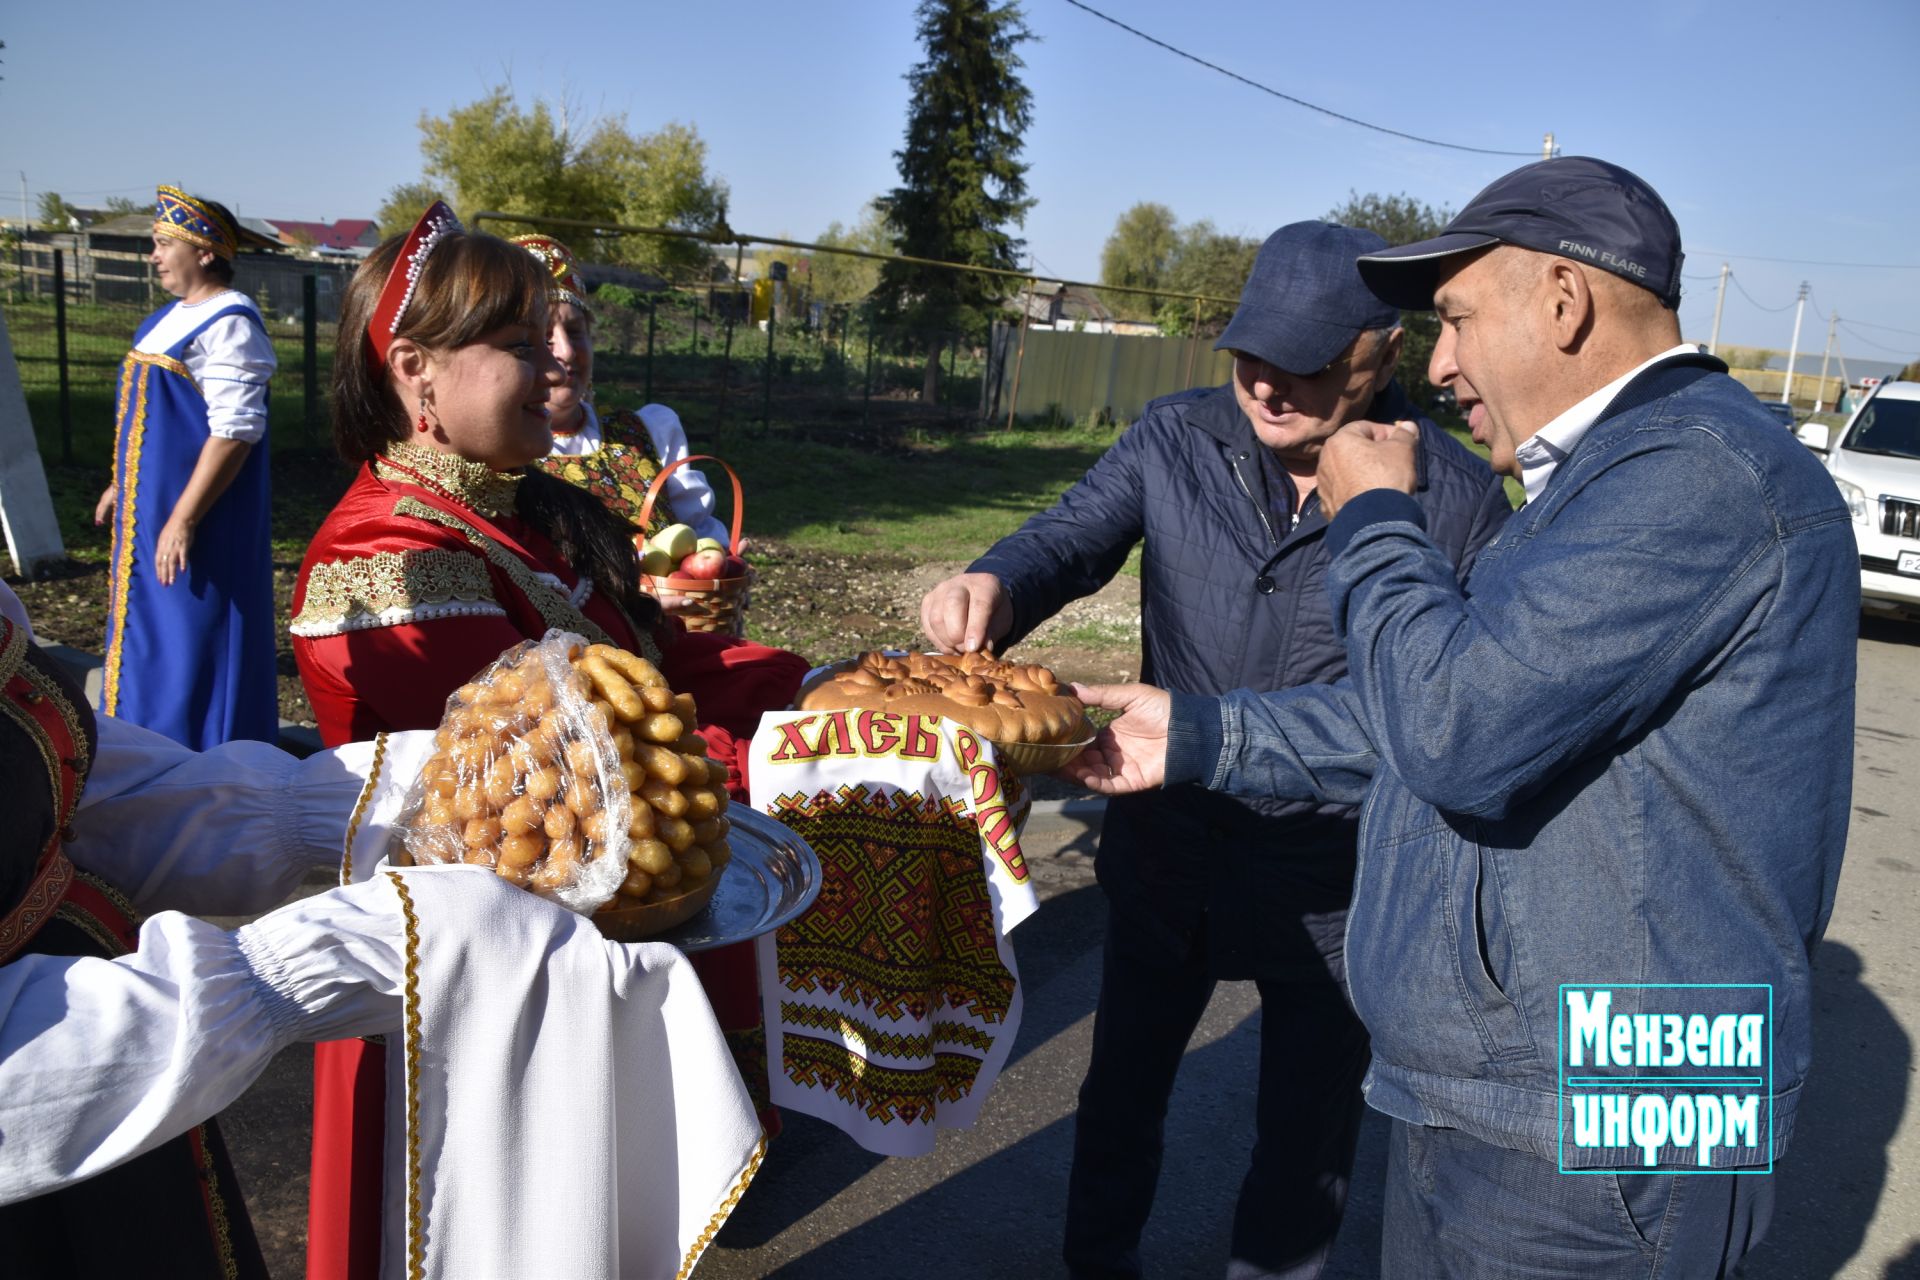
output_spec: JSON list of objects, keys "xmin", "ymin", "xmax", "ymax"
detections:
[{"xmin": 344, "ymin": 735, "xmax": 762, "ymax": 1280}]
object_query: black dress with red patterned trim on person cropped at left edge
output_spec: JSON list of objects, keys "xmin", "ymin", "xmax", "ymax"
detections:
[{"xmin": 0, "ymin": 616, "xmax": 267, "ymax": 1280}]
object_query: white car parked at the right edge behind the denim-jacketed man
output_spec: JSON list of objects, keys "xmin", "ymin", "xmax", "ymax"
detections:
[{"xmin": 1795, "ymin": 382, "xmax": 1920, "ymax": 616}]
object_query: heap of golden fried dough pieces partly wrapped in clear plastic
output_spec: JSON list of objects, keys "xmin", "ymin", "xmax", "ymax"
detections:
[{"xmin": 394, "ymin": 631, "xmax": 730, "ymax": 915}]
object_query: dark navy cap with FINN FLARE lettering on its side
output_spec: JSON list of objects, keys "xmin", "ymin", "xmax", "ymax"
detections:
[{"xmin": 1359, "ymin": 155, "xmax": 1684, "ymax": 311}]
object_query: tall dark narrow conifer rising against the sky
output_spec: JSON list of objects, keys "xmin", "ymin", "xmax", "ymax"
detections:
[{"xmin": 879, "ymin": 0, "xmax": 1033, "ymax": 401}]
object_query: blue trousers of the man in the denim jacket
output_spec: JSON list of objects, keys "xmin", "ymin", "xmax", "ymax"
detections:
[{"xmin": 1380, "ymin": 1121, "xmax": 1774, "ymax": 1280}]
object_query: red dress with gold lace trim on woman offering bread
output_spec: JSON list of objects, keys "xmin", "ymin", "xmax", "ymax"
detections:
[{"xmin": 292, "ymin": 441, "xmax": 804, "ymax": 1280}]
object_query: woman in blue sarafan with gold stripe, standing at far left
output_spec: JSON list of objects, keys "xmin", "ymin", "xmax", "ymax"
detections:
[{"xmin": 94, "ymin": 186, "xmax": 280, "ymax": 750}]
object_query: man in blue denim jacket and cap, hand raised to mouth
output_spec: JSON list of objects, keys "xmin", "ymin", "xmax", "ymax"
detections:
[{"xmin": 1071, "ymin": 157, "xmax": 1859, "ymax": 1278}]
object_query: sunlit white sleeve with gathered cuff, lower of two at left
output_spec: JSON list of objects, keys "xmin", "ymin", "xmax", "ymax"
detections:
[{"xmin": 0, "ymin": 877, "xmax": 405, "ymax": 1203}]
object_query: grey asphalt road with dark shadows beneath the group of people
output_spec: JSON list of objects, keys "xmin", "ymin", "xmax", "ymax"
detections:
[{"xmin": 223, "ymin": 620, "xmax": 1920, "ymax": 1280}]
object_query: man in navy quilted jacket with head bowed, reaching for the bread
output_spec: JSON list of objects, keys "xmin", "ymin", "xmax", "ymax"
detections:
[{"xmin": 922, "ymin": 223, "xmax": 1511, "ymax": 1276}]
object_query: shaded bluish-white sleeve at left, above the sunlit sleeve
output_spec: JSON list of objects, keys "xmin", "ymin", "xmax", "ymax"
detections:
[{"xmin": 65, "ymin": 716, "xmax": 432, "ymax": 915}]
